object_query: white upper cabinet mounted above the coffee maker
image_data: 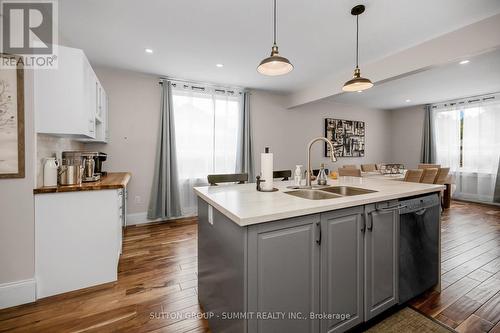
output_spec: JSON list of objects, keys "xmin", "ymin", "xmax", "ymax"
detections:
[{"xmin": 34, "ymin": 46, "xmax": 108, "ymax": 142}]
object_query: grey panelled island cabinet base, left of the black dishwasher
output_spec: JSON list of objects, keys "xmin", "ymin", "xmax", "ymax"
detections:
[{"xmin": 198, "ymin": 198, "xmax": 399, "ymax": 333}]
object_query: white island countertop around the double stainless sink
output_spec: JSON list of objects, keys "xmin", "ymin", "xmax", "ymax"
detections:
[{"xmin": 194, "ymin": 177, "xmax": 444, "ymax": 227}]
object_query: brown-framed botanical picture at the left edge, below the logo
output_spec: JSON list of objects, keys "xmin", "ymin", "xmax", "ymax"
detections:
[{"xmin": 0, "ymin": 54, "xmax": 25, "ymax": 178}]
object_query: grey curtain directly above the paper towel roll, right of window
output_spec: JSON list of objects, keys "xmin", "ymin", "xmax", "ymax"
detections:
[{"xmin": 235, "ymin": 92, "xmax": 255, "ymax": 182}]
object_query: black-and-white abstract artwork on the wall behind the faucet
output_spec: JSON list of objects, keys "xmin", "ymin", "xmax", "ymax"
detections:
[{"xmin": 325, "ymin": 118, "xmax": 365, "ymax": 157}]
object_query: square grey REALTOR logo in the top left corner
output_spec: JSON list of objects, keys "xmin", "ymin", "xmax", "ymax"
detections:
[{"xmin": 0, "ymin": 0, "xmax": 57, "ymax": 68}]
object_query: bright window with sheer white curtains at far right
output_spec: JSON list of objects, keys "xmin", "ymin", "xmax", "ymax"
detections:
[{"xmin": 432, "ymin": 97, "xmax": 500, "ymax": 202}]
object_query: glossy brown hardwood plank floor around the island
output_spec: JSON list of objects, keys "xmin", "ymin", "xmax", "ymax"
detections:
[{"xmin": 0, "ymin": 202, "xmax": 500, "ymax": 333}]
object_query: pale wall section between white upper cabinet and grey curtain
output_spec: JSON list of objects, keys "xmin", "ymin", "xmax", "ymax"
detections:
[{"xmin": 85, "ymin": 67, "xmax": 161, "ymax": 214}]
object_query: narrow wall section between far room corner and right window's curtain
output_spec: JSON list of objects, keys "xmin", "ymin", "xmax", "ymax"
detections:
[{"xmin": 390, "ymin": 105, "xmax": 425, "ymax": 169}]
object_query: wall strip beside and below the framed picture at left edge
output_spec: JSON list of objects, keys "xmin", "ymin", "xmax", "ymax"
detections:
[{"xmin": 0, "ymin": 70, "xmax": 35, "ymax": 308}]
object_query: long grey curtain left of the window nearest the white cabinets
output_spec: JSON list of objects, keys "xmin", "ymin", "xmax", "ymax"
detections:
[{"xmin": 148, "ymin": 80, "xmax": 181, "ymax": 219}]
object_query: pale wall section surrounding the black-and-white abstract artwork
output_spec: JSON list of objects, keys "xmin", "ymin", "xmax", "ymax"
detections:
[{"xmin": 250, "ymin": 91, "xmax": 391, "ymax": 173}]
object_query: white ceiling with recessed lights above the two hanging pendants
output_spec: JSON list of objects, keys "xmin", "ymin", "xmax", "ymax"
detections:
[{"xmin": 59, "ymin": 0, "xmax": 500, "ymax": 92}]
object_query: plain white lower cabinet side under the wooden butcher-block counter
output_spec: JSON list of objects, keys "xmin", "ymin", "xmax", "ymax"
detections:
[{"xmin": 35, "ymin": 190, "xmax": 121, "ymax": 298}]
